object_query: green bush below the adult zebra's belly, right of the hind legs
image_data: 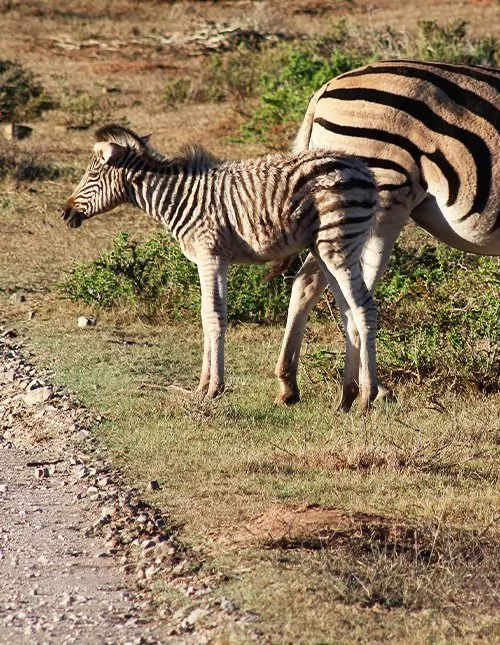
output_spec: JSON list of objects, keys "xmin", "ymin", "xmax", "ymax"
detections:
[{"xmin": 376, "ymin": 244, "xmax": 500, "ymax": 391}]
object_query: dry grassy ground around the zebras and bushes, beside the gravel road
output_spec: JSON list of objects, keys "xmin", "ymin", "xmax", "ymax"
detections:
[{"xmin": 0, "ymin": 0, "xmax": 500, "ymax": 644}]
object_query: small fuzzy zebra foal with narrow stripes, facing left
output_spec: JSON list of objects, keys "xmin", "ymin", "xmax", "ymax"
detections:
[{"xmin": 62, "ymin": 124, "xmax": 378, "ymax": 410}]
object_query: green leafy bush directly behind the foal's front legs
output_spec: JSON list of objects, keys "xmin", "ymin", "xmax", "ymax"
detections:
[{"xmin": 59, "ymin": 233, "xmax": 300, "ymax": 322}]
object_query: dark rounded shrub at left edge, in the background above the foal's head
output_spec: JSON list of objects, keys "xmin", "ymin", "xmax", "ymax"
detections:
[{"xmin": 0, "ymin": 60, "xmax": 52, "ymax": 122}]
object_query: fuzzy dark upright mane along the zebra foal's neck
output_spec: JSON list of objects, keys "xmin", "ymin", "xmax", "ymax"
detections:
[{"xmin": 95, "ymin": 123, "xmax": 221, "ymax": 171}]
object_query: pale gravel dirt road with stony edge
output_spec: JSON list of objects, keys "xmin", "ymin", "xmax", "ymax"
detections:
[{"xmin": 0, "ymin": 329, "xmax": 250, "ymax": 645}]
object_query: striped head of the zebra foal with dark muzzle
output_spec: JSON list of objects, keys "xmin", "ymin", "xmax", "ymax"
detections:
[{"xmin": 61, "ymin": 124, "xmax": 149, "ymax": 228}]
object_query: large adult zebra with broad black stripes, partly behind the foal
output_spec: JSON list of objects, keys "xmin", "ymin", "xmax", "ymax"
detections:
[{"xmin": 275, "ymin": 60, "xmax": 500, "ymax": 404}]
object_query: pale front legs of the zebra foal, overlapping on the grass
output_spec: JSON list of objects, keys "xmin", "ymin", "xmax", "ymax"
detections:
[{"xmin": 198, "ymin": 257, "xmax": 228, "ymax": 399}]
